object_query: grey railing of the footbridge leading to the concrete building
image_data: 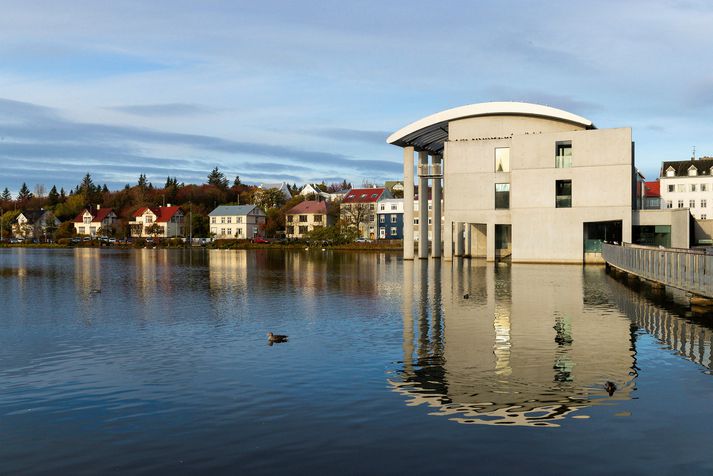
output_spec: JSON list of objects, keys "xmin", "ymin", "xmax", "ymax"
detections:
[{"xmin": 602, "ymin": 243, "xmax": 713, "ymax": 298}]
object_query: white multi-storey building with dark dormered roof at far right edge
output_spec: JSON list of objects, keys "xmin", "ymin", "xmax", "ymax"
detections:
[{"xmin": 659, "ymin": 157, "xmax": 713, "ymax": 220}]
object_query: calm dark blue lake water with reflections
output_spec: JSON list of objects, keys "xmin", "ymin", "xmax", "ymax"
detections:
[{"xmin": 0, "ymin": 249, "xmax": 713, "ymax": 474}]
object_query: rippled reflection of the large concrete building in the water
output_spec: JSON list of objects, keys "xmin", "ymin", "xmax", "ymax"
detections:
[{"xmin": 391, "ymin": 260, "xmax": 636, "ymax": 427}]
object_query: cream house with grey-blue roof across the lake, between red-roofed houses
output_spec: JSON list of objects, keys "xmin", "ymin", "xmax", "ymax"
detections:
[{"xmin": 208, "ymin": 205, "xmax": 266, "ymax": 240}]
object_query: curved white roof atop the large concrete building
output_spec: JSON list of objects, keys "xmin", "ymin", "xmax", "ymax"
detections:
[{"xmin": 386, "ymin": 102, "xmax": 595, "ymax": 153}]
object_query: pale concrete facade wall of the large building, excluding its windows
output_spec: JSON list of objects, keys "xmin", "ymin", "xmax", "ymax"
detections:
[{"xmin": 444, "ymin": 116, "xmax": 633, "ymax": 263}]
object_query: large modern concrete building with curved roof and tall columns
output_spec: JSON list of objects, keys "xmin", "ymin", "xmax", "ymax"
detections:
[{"xmin": 387, "ymin": 102, "xmax": 688, "ymax": 263}]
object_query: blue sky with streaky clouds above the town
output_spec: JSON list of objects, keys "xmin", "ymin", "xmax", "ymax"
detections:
[{"xmin": 0, "ymin": 0, "xmax": 713, "ymax": 192}]
